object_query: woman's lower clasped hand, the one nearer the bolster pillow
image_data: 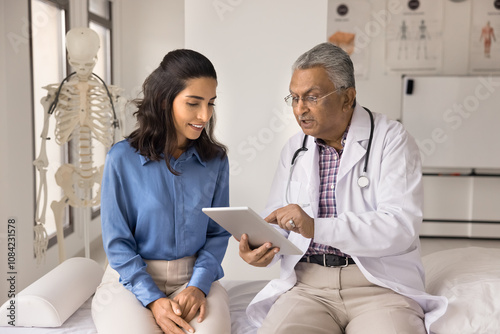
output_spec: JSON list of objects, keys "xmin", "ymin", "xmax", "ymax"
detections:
[{"xmin": 148, "ymin": 298, "xmax": 194, "ymax": 334}]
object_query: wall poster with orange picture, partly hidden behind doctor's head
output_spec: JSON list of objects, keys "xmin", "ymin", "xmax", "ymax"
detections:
[{"xmin": 326, "ymin": 0, "xmax": 374, "ymax": 79}]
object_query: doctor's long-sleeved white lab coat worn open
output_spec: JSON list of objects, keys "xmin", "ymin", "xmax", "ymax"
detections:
[{"xmin": 247, "ymin": 103, "xmax": 448, "ymax": 332}]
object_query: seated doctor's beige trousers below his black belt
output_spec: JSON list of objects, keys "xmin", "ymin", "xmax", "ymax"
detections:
[{"xmin": 258, "ymin": 262, "xmax": 425, "ymax": 334}]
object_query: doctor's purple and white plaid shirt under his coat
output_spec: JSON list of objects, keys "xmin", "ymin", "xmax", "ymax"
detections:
[{"xmin": 305, "ymin": 127, "xmax": 349, "ymax": 257}]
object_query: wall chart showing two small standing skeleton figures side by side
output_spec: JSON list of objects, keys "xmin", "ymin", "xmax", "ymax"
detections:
[{"xmin": 386, "ymin": 0, "xmax": 443, "ymax": 73}]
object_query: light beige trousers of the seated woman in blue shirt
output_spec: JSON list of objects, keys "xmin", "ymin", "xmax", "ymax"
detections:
[{"xmin": 92, "ymin": 257, "xmax": 231, "ymax": 334}]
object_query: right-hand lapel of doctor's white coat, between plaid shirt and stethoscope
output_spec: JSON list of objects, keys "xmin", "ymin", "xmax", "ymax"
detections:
[{"xmin": 337, "ymin": 103, "xmax": 370, "ymax": 182}]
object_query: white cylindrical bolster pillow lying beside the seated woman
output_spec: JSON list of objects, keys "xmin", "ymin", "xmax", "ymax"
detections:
[{"xmin": 0, "ymin": 257, "xmax": 104, "ymax": 327}]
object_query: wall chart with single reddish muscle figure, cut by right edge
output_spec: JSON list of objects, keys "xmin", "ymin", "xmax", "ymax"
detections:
[{"xmin": 469, "ymin": 0, "xmax": 500, "ymax": 74}]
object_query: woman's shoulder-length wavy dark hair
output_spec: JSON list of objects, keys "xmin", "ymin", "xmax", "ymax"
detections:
[{"xmin": 127, "ymin": 49, "xmax": 227, "ymax": 175}]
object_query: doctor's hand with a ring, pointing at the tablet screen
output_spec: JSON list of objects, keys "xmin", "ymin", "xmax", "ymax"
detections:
[{"xmin": 264, "ymin": 204, "xmax": 314, "ymax": 238}]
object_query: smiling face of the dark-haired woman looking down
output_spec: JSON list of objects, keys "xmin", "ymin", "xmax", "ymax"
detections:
[{"xmin": 172, "ymin": 77, "xmax": 217, "ymax": 148}]
